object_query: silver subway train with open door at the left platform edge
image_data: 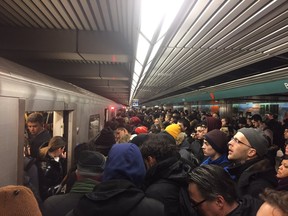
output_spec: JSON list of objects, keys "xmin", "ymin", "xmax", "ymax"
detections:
[{"xmin": 0, "ymin": 58, "xmax": 123, "ymax": 186}]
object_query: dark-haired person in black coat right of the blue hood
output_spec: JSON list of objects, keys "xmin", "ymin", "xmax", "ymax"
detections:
[{"xmin": 140, "ymin": 133, "xmax": 195, "ymax": 216}]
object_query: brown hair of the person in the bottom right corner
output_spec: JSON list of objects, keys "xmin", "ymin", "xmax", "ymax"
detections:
[{"xmin": 260, "ymin": 188, "xmax": 288, "ymax": 214}]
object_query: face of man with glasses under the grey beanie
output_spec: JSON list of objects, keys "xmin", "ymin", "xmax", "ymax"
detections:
[{"xmin": 228, "ymin": 132, "xmax": 251, "ymax": 162}]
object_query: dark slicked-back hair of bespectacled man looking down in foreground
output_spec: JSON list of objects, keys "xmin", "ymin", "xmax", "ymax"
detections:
[{"xmin": 188, "ymin": 165, "xmax": 238, "ymax": 204}]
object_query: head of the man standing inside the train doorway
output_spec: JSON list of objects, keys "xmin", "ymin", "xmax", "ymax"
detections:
[{"xmin": 26, "ymin": 112, "xmax": 44, "ymax": 136}]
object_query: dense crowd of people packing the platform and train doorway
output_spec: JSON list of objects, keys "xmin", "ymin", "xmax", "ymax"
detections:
[{"xmin": 0, "ymin": 109, "xmax": 288, "ymax": 216}]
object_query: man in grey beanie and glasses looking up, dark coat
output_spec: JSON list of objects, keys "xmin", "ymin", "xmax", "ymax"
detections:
[{"xmin": 228, "ymin": 128, "xmax": 277, "ymax": 198}]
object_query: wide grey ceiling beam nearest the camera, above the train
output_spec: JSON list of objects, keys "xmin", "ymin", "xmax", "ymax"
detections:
[{"xmin": 0, "ymin": 28, "xmax": 132, "ymax": 63}]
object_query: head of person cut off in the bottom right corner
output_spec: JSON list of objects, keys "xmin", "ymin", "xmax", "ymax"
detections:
[{"xmin": 256, "ymin": 188, "xmax": 288, "ymax": 216}]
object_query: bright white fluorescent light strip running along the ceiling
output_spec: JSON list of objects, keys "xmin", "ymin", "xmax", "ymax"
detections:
[{"xmin": 130, "ymin": 0, "xmax": 184, "ymax": 102}]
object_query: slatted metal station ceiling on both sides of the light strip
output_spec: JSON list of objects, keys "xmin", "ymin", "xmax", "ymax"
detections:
[{"xmin": 0, "ymin": 0, "xmax": 288, "ymax": 105}]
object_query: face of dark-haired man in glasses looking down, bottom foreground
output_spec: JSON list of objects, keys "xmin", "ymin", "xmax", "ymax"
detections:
[{"xmin": 188, "ymin": 183, "xmax": 220, "ymax": 216}]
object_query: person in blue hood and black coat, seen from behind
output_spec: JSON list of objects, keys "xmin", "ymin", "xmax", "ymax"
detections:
[{"xmin": 66, "ymin": 143, "xmax": 164, "ymax": 216}]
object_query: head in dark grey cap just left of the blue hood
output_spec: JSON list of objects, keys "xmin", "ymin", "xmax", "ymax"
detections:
[{"xmin": 76, "ymin": 150, "xmax": 106, "ymax": 180}]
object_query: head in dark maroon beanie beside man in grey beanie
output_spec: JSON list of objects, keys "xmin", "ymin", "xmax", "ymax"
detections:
[{"xmin": 202, "ymin": 129, "xmax": 228, "ymax": 160}]
